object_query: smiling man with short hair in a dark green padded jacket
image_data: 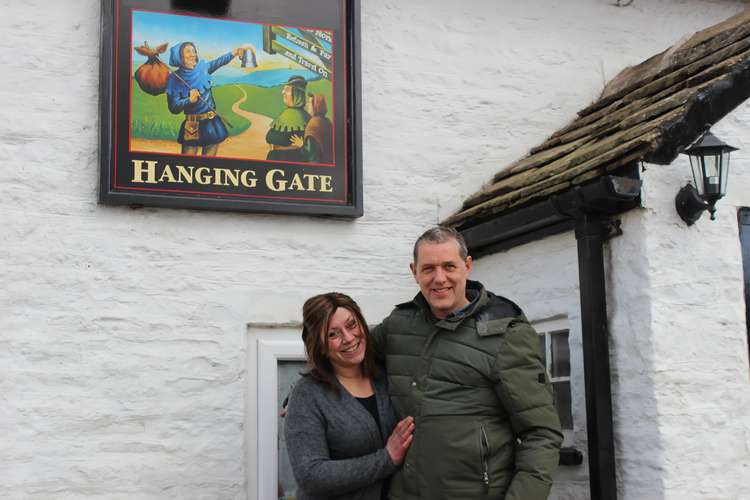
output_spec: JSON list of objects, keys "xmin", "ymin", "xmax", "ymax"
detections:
[{"xmin": 372, "ymin": 227, "xmax": 562, "ymax": 500}]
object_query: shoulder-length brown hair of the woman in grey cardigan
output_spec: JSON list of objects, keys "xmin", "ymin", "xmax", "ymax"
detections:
[{"xmin": 302, "ymin": 292, "xmax": 375, "ymax": 392}]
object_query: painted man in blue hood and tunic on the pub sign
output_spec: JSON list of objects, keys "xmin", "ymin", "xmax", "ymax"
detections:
[{"xmin": 166, "ymin": 42, "xmax": 245, "ymax": 156}]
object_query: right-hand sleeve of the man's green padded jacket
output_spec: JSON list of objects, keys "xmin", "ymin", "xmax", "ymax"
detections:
[{"xmin": 495, "ymin": 319, "xmax": 563, "ymax": 500}]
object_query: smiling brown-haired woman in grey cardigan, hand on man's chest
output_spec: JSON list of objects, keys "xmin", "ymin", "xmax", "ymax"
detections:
[{"xmin": 284, "ymin": 292, "xmax": 414, "ymax": 500}]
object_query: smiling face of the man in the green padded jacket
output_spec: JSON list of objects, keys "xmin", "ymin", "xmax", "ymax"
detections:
[{"xmin": 411, "ymin": 240, "xmax": 472, "ymax": 318}]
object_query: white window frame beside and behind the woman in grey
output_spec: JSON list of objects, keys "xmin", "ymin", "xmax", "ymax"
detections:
[{"xmin": 245, "ymin": 323, "xmax": 305, "ymax": 500}]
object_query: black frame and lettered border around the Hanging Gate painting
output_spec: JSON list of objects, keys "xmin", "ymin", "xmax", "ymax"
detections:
[{"xmin": 99, "ymin": 0, "xmax": 363, "ymax": 218}]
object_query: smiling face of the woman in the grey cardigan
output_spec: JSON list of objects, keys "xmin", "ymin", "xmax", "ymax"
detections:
[{"xmin": 323, "ymin": 307, "xmax": 367, "ymax": 371}]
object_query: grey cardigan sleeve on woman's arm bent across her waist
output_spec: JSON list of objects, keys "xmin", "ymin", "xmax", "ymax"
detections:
[{"xmin": 284, "ymin": 383, "xmax": 397, "ymax": 498}]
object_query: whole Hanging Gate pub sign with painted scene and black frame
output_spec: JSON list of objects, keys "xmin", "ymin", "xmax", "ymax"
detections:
[{"xmin": 99, "ymin": 0, "xmax": 362, "ymax": 217}]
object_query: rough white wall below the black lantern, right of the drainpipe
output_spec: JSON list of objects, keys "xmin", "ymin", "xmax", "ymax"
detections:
[{"xmin": 612, "ymin": 99, "xmax": 750, "ymax": 499}]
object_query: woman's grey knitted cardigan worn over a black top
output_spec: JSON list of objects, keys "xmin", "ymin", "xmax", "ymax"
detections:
[{"xmin": 284, "ymin": 376, "xmax": 397, "ymax": 500}]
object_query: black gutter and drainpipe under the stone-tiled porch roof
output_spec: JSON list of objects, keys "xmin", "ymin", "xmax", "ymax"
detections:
[{"xmin": 461, "ymin": 175, "xmax": 641, "ymax": 500}]
